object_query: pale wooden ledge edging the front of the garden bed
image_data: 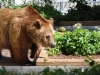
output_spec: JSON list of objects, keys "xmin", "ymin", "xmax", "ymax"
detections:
[{"xmin": 36, "ymin": 50, "xmax": 100, "ymax": 66}]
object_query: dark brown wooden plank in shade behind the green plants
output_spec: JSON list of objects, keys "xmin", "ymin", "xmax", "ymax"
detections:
[{"xmin": 59, "ymin": 21, "xmax": 100, "ymax": 26}]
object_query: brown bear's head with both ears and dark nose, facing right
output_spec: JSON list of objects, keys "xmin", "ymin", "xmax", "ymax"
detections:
[{"xmin": 26, "ymin": 18, "xmax": 56, "ymax": 48}]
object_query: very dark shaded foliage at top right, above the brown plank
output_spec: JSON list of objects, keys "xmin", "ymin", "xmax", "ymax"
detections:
[{"xmin": 64, "ymin": 0, "xmax": 100, "ymax": 21}]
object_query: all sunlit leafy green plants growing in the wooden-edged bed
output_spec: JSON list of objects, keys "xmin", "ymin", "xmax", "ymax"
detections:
[{"xmin": 49, "ymin": 28, "xmax": 100, "ymax": 55}]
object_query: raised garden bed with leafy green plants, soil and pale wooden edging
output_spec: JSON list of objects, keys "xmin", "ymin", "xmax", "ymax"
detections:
[{"xmin": 36, "ymin": 27, "xmax": 100, "ymax": 66}]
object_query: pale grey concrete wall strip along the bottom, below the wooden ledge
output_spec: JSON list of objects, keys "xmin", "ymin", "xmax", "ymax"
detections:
[{"xmin": 0, "ymin": 66, "xmax": 88, "ymax": 75}]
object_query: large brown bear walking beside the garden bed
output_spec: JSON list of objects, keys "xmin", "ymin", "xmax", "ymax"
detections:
[{"xmin": 0, "ymin": 6, "xmax": 56, "ymax": 63}]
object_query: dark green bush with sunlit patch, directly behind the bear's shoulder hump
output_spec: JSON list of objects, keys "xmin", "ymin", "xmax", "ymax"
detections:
[{"xmin": 33, "ymin": 5, "xmax": 63, "ymax": 23}]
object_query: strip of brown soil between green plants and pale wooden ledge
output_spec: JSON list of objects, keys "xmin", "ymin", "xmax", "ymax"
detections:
[{"xmin": 49, "ymin": 54, "xmax": 100, "ymax": 59}]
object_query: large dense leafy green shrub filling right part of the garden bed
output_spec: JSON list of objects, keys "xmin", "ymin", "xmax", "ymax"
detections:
[{"xmin": 63, "ymin": 28, "xmax": 100, "ymax": 55}]
